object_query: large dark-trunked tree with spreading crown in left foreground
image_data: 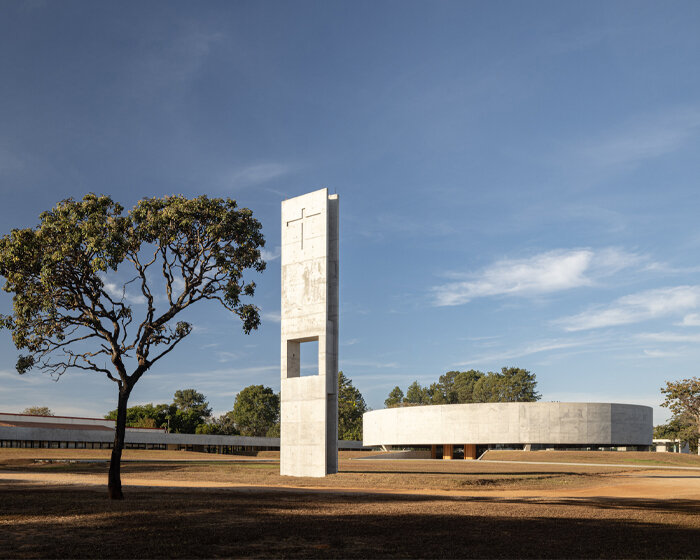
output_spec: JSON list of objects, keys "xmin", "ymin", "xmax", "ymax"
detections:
[{"xmin": 0, "ymin": 194, "xmax": 265, "ymax": 498}]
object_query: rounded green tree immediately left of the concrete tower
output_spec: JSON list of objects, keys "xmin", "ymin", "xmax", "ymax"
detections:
[{"xmin": 232, "ymin": 385, "xmax": 280, "ymax": 437}]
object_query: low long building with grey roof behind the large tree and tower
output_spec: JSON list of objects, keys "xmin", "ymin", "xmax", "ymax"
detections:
[{"xmin": 0, "ymin": 413, "xmax": 370, "ymax": 453}]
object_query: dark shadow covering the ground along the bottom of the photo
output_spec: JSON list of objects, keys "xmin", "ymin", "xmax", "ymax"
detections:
[{"xmin": 0, "ymin": 484, "xmax": 700, "ymax": 558}]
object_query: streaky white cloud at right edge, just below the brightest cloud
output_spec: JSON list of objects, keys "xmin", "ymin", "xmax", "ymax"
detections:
[{"xmin": 555, "ymin": 286, "xmax": 700, "ymax": 331}]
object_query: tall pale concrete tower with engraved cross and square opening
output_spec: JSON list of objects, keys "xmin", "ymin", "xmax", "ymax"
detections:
[{"xmin": 280, "ymin": 189, "xmax": 338, "ymax": 477}]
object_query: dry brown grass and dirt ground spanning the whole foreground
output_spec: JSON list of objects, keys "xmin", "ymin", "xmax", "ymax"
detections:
[{"xmin": 0, "ymin": 450, "xmax": 700, "ymax": 558}]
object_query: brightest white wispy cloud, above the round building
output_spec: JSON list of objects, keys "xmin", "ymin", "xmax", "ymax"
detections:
[{"xmin": 432, "ymin": 248, "xmax": 644, "ymax": 306}]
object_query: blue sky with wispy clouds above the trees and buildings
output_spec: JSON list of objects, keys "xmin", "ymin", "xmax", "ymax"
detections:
[{"xmin": 0, "ymin": 0, "xmax": 700, "ymax": 423}]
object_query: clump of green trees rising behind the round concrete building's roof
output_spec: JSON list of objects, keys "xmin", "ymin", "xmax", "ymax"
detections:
[{"xmin": 384, "ymin": 367, "xmax": 541, "ymax": 408}]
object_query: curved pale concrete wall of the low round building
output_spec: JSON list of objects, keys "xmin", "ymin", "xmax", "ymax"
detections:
[{"xmin": 363, "ymin": 402, "xmax": 653, "ymax": 445}]
